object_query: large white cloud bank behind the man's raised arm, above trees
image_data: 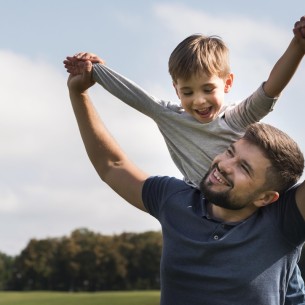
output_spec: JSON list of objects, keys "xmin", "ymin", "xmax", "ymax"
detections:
[{"xmin": 0, "ymin": 51, "xmax": 170, "ymax": 254}]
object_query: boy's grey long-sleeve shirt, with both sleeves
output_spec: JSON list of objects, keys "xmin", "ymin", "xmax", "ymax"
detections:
[{"xmin": 93, "ymin": 64, "xmax": 277, "ymax": 187}]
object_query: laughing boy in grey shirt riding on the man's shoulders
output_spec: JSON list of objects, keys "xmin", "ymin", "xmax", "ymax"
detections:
[{"xmin": 64, "ymin": 17, "xmax": 305, "ymax": 187}]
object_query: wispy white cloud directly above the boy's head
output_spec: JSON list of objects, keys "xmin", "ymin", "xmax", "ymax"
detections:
[{"xmin": 154, "ymin": 3, "xmax": 293, "ymax": 48}]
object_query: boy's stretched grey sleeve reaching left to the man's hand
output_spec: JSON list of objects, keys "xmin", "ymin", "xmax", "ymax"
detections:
[{"xmin": 93, "ymin": 64, "xmax": 170, "ymax": 119}]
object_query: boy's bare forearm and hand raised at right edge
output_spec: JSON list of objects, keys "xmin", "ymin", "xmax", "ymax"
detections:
[{"xmin": 264, "ymin": 16, "xmax": 305, "ymax": 97}]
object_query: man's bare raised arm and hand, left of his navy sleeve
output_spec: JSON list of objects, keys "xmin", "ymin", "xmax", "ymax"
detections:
[{"xmin": 68, "ymin": 62, "xmax": 148, "ymax": 211}]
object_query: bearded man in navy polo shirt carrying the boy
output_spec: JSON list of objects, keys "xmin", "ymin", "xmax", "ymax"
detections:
[{"xmin": 68, "ymin": 62, "xmax": 305, "ymax": 305}]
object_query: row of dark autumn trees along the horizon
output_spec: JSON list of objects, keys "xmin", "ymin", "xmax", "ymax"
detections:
[{"xmin": 0, "ymin": 229, "xmax": 162, "ymax": 291}]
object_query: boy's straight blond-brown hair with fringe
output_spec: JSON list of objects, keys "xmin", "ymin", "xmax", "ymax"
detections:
[{"xmin": 168, "ymin": 34, "xmax": 230, "ymax": 83}]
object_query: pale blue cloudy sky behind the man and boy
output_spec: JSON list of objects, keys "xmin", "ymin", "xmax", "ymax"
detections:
[{"xmin": 0, "ymin": 0, "xmax": 305, "ymax": 255}]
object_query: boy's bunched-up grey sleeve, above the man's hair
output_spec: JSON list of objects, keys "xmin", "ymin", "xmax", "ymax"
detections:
[{"xmin": 225, "ymin": 84, "xmax": 278, "ymax": 130}]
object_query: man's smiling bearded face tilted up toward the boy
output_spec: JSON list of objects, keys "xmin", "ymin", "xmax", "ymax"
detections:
[{"xmin": 200, "ymin": 139, "xmax": 271, "ymax": 210}]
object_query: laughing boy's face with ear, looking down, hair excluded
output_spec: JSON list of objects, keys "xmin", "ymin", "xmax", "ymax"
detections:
[{"xmin": 174, "ymin": 73, "xmax": 233, "ymax": 123}]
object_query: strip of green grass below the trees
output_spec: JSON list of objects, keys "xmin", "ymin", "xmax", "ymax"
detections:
[{"xmin": 0, "ymin": 291, "xmax": 160, "ymax": 305}]
